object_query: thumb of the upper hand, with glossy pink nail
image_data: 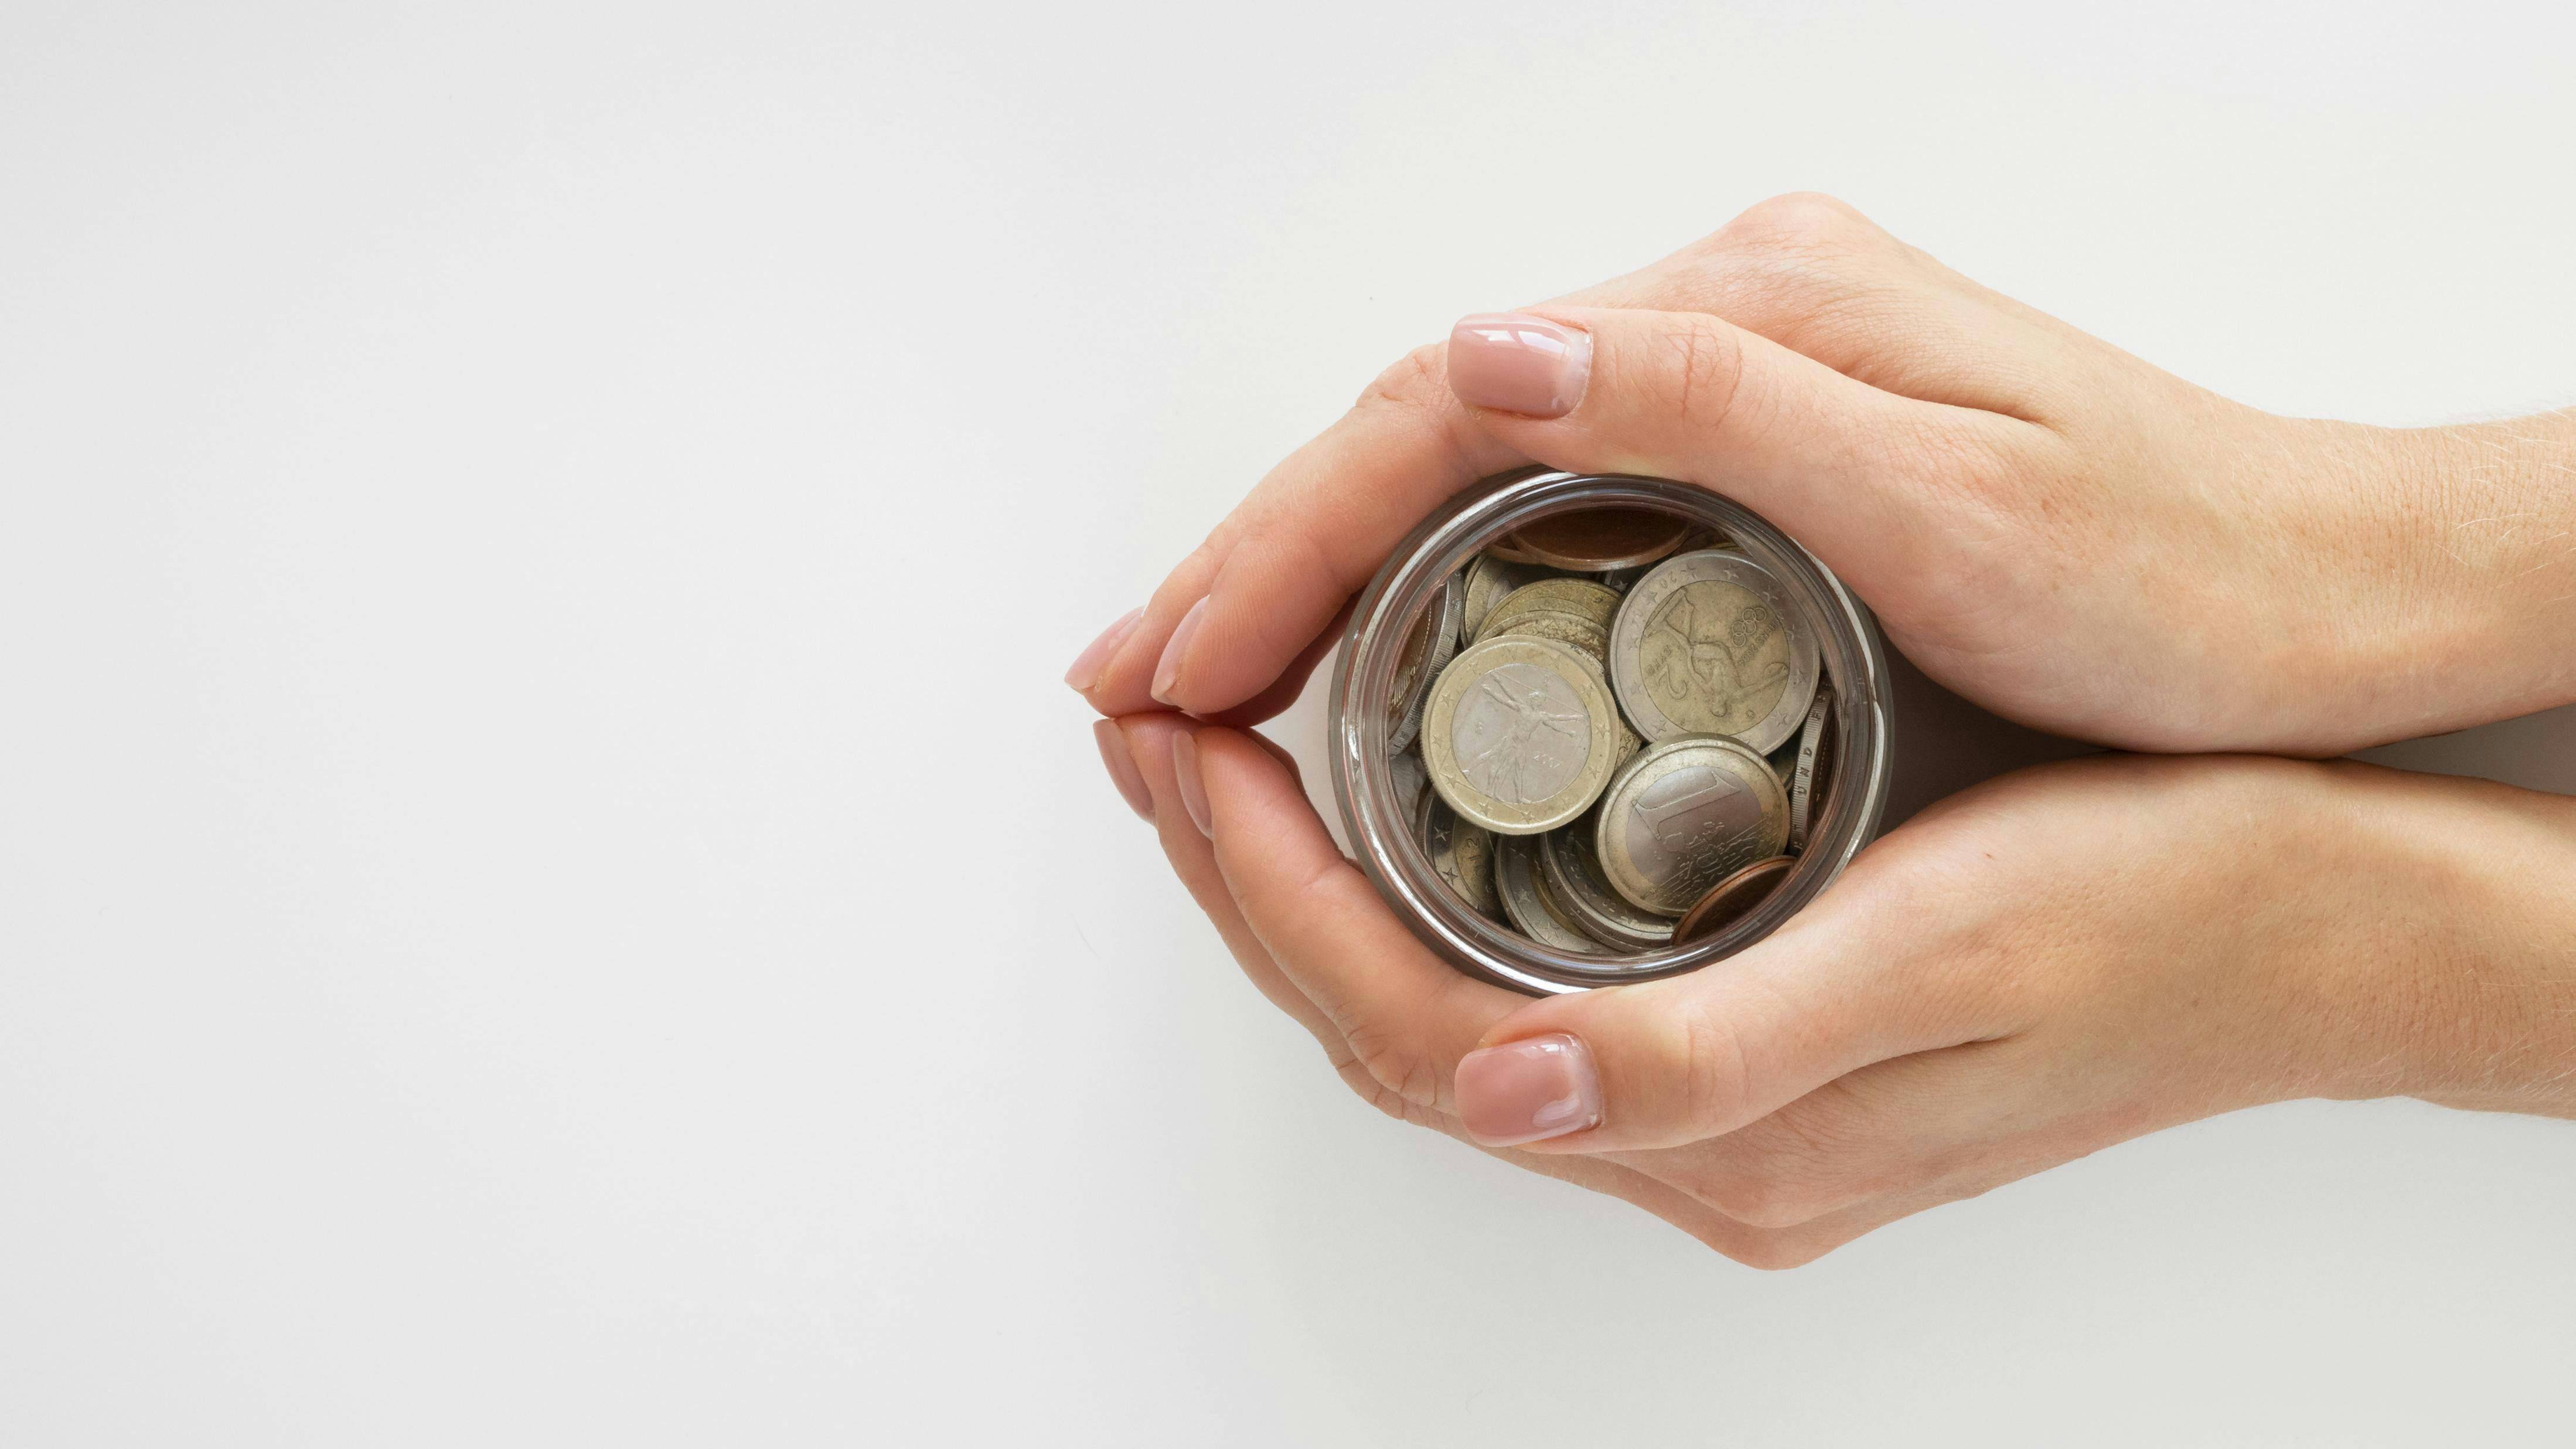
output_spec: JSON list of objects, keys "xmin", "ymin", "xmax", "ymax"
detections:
[{"xmin": 1450, "ymin": 307, "xmax": 2043, "ymax": 577}]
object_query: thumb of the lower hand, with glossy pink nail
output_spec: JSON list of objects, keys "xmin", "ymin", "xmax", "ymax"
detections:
[{"xmin": 1456, "ymin": 856, "xmax": 2028, "ymax": 1152}]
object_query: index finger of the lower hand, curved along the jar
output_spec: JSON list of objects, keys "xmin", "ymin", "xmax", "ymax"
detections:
[{"xmin": 1177, "ymin": 727, "xmax": 1522, "ymax": 1114}]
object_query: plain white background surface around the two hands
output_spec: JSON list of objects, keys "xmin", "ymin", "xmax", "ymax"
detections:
[{"xmin": 0, "ymin": 0, "xmax": 2576, "ymax": 1447}]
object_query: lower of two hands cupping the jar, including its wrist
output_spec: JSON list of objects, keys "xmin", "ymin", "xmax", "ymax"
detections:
[{"xmin": 1098, "ymin": 714, "xmax": 2576, "ymax": 1266}]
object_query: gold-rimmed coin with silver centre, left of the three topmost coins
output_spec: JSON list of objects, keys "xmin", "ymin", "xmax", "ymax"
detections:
[{"xmin": 1422, "ymin": 634, "xmax": 1620, "ymax": 835}]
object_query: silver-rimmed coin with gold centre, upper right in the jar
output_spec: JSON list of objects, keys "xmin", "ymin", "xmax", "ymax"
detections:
[{"xmin": 1610, "ymin": 549, "xmax": 1816, "ymax": 753}]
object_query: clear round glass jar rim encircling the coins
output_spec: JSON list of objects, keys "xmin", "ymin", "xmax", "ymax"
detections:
[{"xmin": 1327, "ymin": 470, "xmax": 1891, "ymax": 995}]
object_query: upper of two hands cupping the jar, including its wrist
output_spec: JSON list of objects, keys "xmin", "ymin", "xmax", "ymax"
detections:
[{"xmin": 1069, "ymin": 196, "xmax": 2576, "ymax": 753}]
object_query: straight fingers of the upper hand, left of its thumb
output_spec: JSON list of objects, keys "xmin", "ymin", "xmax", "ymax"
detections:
[{"xmin": 1066, "ymin": 345, "xmax": 1525, "ymax": 717}]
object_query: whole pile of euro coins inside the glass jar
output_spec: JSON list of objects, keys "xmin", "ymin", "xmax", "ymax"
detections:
[{"xmin": 1388, "ymin": 508, "xmax": 1834, "ymax": 957}]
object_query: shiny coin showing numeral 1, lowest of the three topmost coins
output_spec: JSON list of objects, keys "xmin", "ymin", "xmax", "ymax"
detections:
[{"xmin": 1586, "ymin": 735, "xmax": 1788, "ymax": 915}]
